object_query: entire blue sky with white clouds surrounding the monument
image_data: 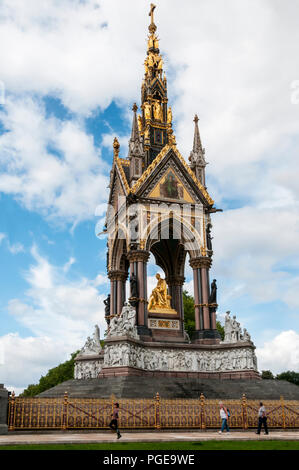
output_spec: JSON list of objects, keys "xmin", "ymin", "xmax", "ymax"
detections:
[{"xmin": 0, "ymin": 0, "xmax": 299, "ymax": 393}]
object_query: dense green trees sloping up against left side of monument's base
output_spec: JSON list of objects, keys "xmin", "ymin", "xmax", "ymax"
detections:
[{"xmin": 20, "ymin": 351, "xmax": 79, "ymax": 397}]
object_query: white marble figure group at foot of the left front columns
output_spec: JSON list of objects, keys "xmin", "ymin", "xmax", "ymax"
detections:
[{"xmin": 107, "ymin": 303, "xmax": 139, "ymax": 339}]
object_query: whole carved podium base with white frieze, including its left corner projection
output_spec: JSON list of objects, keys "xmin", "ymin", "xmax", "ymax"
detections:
[{"xmin": 74, "ymin": 333, "xmax": 259, "ymax": 380}]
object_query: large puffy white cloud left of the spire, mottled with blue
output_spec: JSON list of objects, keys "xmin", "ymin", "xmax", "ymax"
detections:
[{"xmin": 0, "ymin": 97, "xmax": 109, "ymax": 223}]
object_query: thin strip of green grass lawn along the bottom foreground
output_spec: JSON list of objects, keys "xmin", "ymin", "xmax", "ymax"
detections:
[{"xmin": 0, "ymin": 440, "xmax": 299, "ymax": 451}]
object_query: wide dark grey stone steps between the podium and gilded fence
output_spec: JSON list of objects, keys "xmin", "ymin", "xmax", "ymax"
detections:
[{"xmin": 38, "ymin": 376, "xmax": 299, "ymax": 400}]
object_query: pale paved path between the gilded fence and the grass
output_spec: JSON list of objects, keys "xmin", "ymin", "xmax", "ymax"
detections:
[{"xmin": 0, "ymin": 430, "xmax": 299, "ymax": 446}]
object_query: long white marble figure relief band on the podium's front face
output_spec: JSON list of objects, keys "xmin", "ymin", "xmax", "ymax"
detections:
[{"xmin": 104, "ymin": 342, "xmax": 257, "ymax": 372}]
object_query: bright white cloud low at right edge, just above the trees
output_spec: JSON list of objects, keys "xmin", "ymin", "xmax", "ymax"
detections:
[{"xmin": 256, "ymin": 330, "xmax": 299, "ymax": 374}]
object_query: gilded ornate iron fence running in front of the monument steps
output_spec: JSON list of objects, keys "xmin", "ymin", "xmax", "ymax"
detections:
[{"xmin": 8, "ymin": 393, "xmax": 299, "ymax": 431}]
